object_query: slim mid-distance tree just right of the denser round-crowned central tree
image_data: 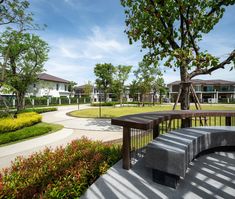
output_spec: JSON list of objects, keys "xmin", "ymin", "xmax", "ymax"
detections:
[{"xmin": 113, "ymin": 65, "xmax": 132, "ymax": 106}]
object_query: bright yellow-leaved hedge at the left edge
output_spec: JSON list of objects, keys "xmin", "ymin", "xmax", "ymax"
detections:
[{"xmin": 0, "ymin": 112, "xmax": 42, "ymax": 133}]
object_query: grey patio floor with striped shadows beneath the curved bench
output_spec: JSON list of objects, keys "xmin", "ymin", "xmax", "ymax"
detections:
[{"xmin": 81, "ymin": 152, "xmax": 235, "ymax": 199}]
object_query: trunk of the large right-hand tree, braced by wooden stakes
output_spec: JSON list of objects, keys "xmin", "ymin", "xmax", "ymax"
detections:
[{"xmin": 180, "ymin": 66, "xmax": 191, "ymax": 110}]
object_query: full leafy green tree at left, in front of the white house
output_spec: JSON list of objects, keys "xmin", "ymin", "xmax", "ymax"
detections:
[{"xmin": 0, "ymin": 30, "xmax": 49, "ymax": 111}]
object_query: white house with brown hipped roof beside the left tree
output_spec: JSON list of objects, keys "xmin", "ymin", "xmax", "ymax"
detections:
[{"xmin": 27, "ymin": 73, "xmax": 71, "ymax": 97}]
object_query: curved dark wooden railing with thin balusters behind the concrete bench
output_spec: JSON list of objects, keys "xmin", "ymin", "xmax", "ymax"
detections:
[{"xmin": 111, "ymin": 110, "xmax": 235, "ymax": 169}]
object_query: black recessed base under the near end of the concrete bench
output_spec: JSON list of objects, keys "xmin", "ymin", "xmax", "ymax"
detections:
[{"xmin": 152, "ymin": 169, "xmax": 180, "ymax": 189}]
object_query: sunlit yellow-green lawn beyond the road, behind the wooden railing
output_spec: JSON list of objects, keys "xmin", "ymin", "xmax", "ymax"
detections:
[{"xmin": 69, "ymin": 104, "xmax": 235, "ymax": 118}]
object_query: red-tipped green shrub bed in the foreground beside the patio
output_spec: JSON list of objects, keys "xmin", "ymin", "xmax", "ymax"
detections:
[{"xmin": 0, "ymin": 138, "xmax": 121, "ymax": 198}]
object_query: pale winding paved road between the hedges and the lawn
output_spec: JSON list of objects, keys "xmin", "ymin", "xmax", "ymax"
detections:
[{"xmin": 0, "ymin": 105, "xmax": 122, "ymax": 169}]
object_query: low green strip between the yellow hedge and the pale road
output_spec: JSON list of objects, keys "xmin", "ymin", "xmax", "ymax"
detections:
[{"xmin": 0, "ymin": 122, "xmax": 63, "ymax": 145}]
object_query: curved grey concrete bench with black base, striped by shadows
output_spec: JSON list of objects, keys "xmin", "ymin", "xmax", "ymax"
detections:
[{"xmin": 145, "ymin": 126, "xmax": 235, "ymax": 188}]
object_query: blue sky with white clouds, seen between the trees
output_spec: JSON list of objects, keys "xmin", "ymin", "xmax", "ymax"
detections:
[{"xmin": 30, "ymin": 0, "xmax": 235, "ymax": 84}]
